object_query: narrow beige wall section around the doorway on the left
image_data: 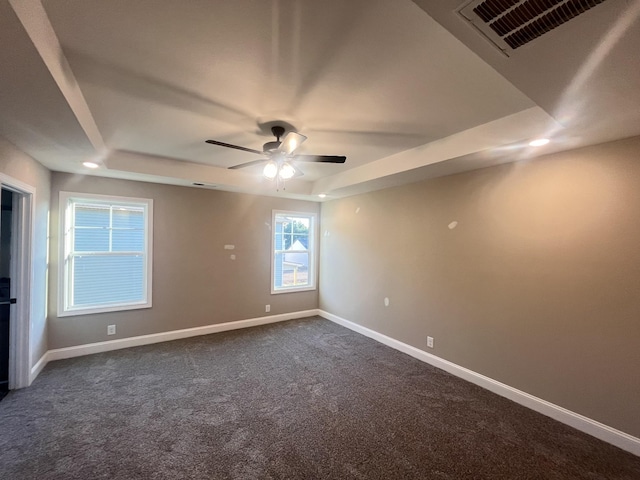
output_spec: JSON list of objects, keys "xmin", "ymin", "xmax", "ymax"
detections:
[{"xmin": 0, "ymin": 138, "xmax": 50, "ymax": 366}]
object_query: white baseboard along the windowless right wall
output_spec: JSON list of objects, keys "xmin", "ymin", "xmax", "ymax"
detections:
[{"xmin": 318, "ymin": 310, "xmax": 640, "ymax": 456}]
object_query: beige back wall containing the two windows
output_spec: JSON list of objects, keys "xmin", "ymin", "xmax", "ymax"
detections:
[{"xmin": 49, "ymin": 173, "xmax": 320, "ymax": 349}]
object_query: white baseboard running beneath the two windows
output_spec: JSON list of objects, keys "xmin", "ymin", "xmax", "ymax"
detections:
[{"xmin": 40, "ymin": 309, "xmax": 318, "ymax": 364}]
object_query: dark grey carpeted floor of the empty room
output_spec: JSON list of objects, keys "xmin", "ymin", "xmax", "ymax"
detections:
[{"xmin": 0, "ymin": 318, "xmax": 640, "ymax": 480}]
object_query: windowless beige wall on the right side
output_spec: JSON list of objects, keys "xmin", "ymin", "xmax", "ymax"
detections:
[{"xmin": 320, "ymin": 137, "xmax": 640, "ymax": 437}]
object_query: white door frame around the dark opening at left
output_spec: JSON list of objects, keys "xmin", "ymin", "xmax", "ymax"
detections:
[{"xmin": 0, "ymin": 173, "xmax": 36, "ymax": 390}]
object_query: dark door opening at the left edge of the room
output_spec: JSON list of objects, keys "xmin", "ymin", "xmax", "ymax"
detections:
[{"xmin": 0, "ymin": 188, "xmax": 15, "ymax": 400}]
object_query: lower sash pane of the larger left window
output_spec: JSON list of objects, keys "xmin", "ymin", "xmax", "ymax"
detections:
[{"xmin": 72, "ymin": 255, "xmax": 144, "ymax": 307}]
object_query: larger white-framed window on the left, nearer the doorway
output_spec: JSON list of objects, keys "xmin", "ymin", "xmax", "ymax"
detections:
[{"xmin": 58, "ymin": 192, "xmax": 153, "ymax": 316}]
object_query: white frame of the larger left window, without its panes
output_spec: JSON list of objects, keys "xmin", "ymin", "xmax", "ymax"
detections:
[{"xmin": 57, "ymin": 192, "xmax": 153, "ymax": 317}]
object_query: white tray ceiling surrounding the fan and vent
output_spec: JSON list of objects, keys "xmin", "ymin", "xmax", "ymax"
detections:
[{"xmin": 0, "ymin": 0, "xmax": 640, "ymax": 199}]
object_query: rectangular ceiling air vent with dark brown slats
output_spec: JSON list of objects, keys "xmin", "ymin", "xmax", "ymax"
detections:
[{"xmin": 458, "ymin": 0, "xmax": 605, "ymax": 55}]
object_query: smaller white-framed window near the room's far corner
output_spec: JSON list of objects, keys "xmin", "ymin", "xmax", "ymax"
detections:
[{"xmin": 271, "ymin": 210, "xmax": 316, "ymax": 293}]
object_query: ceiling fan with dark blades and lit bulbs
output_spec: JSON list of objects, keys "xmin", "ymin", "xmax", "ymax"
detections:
[{"xmin": 206, "ymin": 125, "xmax": 347, "ymax": 181}]
